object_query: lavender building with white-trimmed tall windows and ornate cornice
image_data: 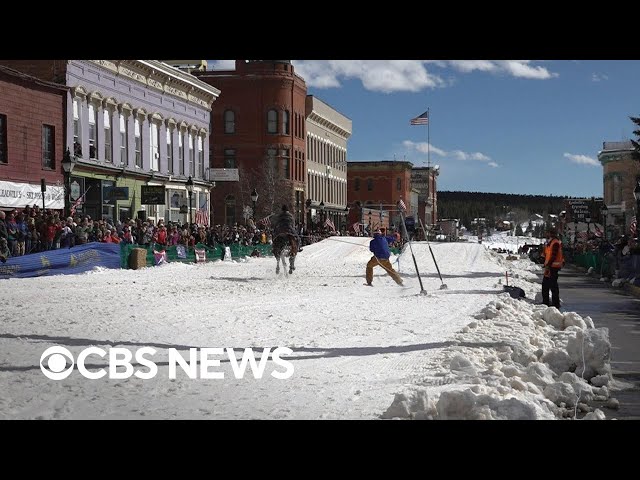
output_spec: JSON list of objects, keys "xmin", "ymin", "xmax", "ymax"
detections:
[{"xmin": 0, "ymin": 60, "xmax": 220, "ymax": 223}]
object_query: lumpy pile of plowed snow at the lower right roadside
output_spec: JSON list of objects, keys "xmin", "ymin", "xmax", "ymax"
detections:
[{"xmin": 382, "ymin": 294, "xmax": 613, "ymax": 420}]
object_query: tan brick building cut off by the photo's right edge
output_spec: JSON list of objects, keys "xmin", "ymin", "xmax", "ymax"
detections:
[{"xmin": 598, "ymin": 141, "xmax": 640, "ymax": 238}]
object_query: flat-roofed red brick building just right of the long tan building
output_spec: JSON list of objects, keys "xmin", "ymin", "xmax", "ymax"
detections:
[{"xmin": 347, "ymin": 161, "xmax": 418, "ymax": 232}]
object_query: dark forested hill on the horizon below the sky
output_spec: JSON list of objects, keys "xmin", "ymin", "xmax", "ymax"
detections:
[{"xmin": 438, "ymin": 191, "xmax": 567, "ymax": 228}]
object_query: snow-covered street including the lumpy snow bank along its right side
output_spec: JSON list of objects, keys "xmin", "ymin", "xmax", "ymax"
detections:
[{"xmin": 0, "ymin": 237, "xmax": 610, "ymax": 419}]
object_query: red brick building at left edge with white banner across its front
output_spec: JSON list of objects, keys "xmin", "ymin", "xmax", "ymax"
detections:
[{"xmin": 0, "ymin": 66, "xmax": 68, "ymax": 210}]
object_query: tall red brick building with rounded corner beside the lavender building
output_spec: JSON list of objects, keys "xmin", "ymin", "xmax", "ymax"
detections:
[{"xmin": 192, "ymin": 60, "xmax": 307, "ymax": 225}]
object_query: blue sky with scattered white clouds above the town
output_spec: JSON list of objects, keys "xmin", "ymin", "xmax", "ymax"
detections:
[{"xmin": 209, "ymin": 60, "xmax": 640, "ymax": 197}]
